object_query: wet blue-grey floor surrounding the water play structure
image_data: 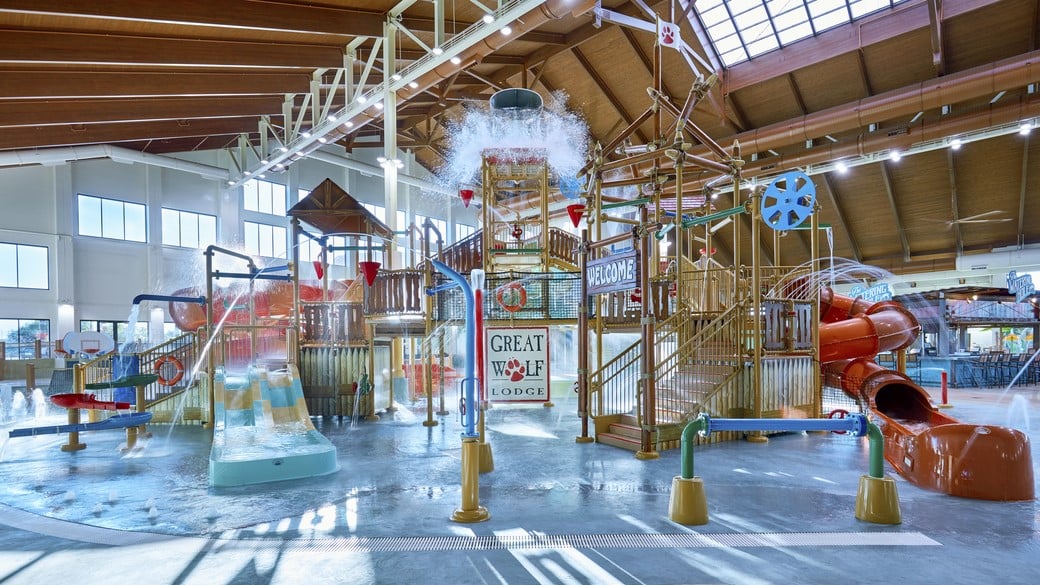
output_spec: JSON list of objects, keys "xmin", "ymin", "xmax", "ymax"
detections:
[{"xmin": 0, "ymin": 388, "xmax": 1040, "ymax": 585}]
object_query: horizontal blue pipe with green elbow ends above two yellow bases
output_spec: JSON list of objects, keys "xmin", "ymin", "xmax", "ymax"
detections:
[{"xmin": 680, "ymin": 413, "xmax": 873, "ymax": 480}]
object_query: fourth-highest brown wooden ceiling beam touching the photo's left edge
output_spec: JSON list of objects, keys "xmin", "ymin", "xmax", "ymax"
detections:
[{"xmin": 0, "ymin": 117, "xmax": 257, "ymax": 150}]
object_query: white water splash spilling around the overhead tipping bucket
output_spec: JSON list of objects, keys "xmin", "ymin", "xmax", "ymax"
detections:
[{"xmin": 438, "ymin": 92, "xmax": 589, "ymax": 187}]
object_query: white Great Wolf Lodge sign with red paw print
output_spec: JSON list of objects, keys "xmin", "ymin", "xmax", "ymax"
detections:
[{"xmin": 484, "ymin": 327, "xmax": 549, "ymax": 402}]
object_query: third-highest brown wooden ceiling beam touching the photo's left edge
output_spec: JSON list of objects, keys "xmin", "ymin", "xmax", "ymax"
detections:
[{"xmin": 0, "ymin": 96, "xmax": 282, "ymax": 127}]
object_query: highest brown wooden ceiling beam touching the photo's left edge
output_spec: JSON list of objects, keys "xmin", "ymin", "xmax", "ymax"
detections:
[{"xmin": 0, "ymin": 30, "xmax": 343, "ymax": 69}]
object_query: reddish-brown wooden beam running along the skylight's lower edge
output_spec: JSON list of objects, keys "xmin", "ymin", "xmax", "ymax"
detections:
[{"xmin": 725, "ymin": 0, "xmax": 1002, "ymax": 92}]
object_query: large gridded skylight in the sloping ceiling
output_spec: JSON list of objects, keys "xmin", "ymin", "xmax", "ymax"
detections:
[{"xmin": 682, "ymin": 0, "xmax": 904, "ymax": 67}]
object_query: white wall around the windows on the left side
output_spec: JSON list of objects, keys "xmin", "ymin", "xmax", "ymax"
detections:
[{"xmin": 0, "ymin": 149, "xmax": 477, "ymax": 340}]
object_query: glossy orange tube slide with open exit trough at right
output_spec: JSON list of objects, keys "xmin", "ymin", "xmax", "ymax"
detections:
[{"xmin": 820, "ymin": 288, "xmax": 1034, "ymax": 501}]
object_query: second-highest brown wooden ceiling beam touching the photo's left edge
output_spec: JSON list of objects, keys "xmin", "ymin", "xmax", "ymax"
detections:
[{"xmin": 0, "ymin": 71, "xmax": 311, "ymax": 98}]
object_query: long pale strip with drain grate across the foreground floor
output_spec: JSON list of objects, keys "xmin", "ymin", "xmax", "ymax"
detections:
[{"xmin": 222, "ymin": 532, "xmax": 941, "ymax": 553}]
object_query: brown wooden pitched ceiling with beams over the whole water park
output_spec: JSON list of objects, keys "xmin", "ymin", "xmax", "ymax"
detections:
[{"xmin": 0, "ymin": 0, "xmax": 1040, "ymax": 272}]
